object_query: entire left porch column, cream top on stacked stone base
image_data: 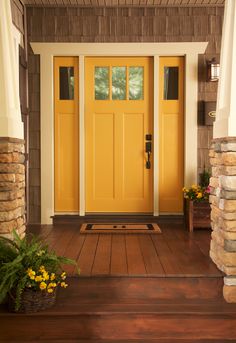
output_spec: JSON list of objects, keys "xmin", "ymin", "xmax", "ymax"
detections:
[{"xmin": 0, "ymin": 0, "xmax": 25, "ymax": 238}]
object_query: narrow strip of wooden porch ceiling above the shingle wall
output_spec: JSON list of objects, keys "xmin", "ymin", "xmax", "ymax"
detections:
[{"xmin": 23, "ymin": 0, "xmax": 225, "ymax": 7}]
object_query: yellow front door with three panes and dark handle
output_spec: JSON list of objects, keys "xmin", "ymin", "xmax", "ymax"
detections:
[{"xmin": 85, "ymin": 57, "xmax": 153, "ymax": 213}]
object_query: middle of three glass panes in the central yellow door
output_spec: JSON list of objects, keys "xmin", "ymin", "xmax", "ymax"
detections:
[{"xmin": 112, "ymin": 67, "xmax": 126, "ymax": 100}]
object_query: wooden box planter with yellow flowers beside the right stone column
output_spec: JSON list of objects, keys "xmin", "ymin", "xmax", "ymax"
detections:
[{"xmin": 183, "ymin": 181, "xmax": 211, "ymax": 232}]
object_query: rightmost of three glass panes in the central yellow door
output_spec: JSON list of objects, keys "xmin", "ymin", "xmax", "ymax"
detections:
[{"xmin": 129, "ymin": 67, "xmax": 143, "ymax": 100}]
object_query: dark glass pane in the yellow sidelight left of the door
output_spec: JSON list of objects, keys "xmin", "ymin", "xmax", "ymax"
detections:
[{"xmin": 59, "ymin": 67, "xmax": 74, "ymax": 100}]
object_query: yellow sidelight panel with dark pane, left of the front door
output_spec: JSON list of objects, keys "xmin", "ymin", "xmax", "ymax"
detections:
[{"xmin": 54, "ymin": 57, "xmax": 79, "ymax": 212}]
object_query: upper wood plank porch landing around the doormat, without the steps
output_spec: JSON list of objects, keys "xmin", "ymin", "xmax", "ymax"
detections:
[{"xmin": 28, "ymin": 220, "xmax": 223, "ymax": 277}]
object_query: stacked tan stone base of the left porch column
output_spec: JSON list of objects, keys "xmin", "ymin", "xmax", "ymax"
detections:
[{"xmin": 0, "ymin": 138, "xmax": 26, "ymax": 238}]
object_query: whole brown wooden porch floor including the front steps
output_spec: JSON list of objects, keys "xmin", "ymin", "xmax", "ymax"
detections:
[{"xmin": 0, "ymin": 220, "xmax": 236, "ymax": 343}]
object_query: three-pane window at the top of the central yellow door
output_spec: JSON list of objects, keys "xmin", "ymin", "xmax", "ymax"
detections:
[{"xmin": 94, "ymin": 66, "xmax": 144, "ymax": 100}]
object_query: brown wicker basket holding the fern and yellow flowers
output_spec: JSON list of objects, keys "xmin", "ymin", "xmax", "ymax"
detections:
[{"xmin": 8, "ymin": 288, "xmax": 56, "ymax": 313}]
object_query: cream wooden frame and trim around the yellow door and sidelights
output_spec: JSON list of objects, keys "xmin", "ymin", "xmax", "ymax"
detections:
[{"xmin": 31, "ymin": 42, "xmax": 208, "ymax": 224}]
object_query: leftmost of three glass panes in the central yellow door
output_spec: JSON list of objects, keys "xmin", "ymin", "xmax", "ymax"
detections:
[{"xmin": 94, "ymin": 67, "xmax": 109, "ymax": 100}]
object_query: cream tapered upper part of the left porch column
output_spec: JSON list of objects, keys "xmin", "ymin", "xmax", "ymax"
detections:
[{"xmin": 0, "ymin": 1, "xmax": 23, "ymax": 139}]
